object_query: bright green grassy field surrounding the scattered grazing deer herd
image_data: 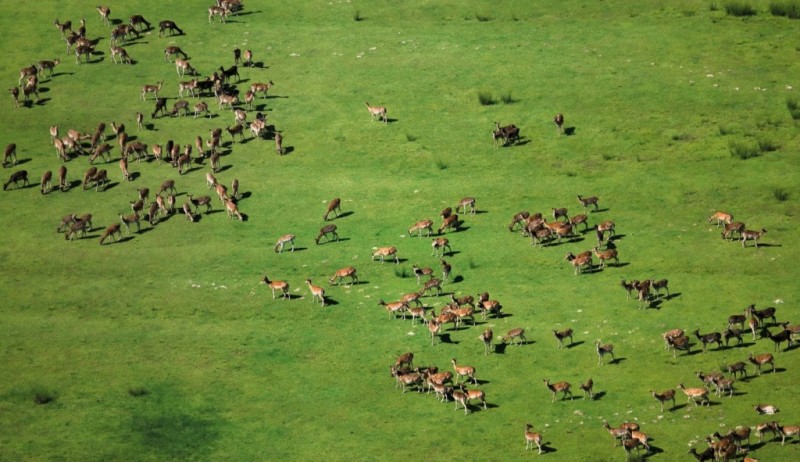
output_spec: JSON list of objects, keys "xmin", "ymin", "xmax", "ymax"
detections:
[{"xmin": 0, "ymin": 0, "xmax": 800, "ymax": 461}]
